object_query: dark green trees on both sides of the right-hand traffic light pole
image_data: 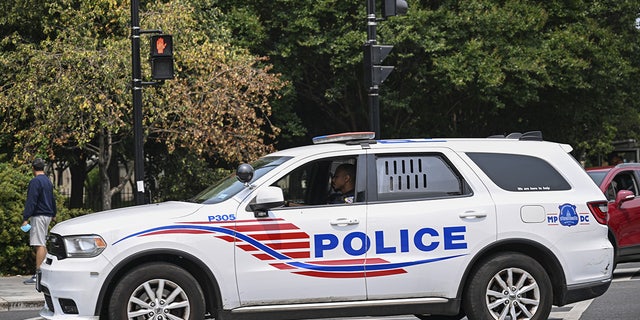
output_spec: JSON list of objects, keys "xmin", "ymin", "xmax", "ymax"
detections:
[{"xmin": 216, "ymin": 0, "xmax": 640, "ymax": 160}]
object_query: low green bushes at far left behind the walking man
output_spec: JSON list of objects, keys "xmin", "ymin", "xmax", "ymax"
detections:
[{"xmin": 0, "ymin": 162, "xmax": 85, "ymax": 275}]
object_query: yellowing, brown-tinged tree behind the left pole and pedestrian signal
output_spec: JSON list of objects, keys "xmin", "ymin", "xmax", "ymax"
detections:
[{"xmin": 0, "ymin": 0, "xmax": 282, "ymax": 209}]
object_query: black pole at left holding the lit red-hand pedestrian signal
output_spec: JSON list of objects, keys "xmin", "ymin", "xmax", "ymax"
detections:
[{"xmin": 131, "ymin": 0, "xmax": 145, "ymax": 205}]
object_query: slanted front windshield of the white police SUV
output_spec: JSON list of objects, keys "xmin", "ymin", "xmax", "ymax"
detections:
[{"xmin": 190, "ymin": 157, "xmax": 291, "ymax": 204}]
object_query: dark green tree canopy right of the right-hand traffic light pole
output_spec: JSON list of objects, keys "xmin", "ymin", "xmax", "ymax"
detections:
[{"xmin": 387, "ymin": 1, "xmax": 638, "ymax": 160}]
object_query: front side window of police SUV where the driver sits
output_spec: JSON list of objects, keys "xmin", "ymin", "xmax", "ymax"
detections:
[{"xmin": 273, "ymin": 157, "xmax": 363, "ymax": 206}]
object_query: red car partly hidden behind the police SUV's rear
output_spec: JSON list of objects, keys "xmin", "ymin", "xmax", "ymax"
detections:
[{"xmin": 587, "ymin": 163, "xmax": 640, "ymax": 263}]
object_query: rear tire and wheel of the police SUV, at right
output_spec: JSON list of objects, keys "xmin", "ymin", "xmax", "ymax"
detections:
[{"xmin": 462, "ymin": 252, "xmax": 553, "ymax": 320}]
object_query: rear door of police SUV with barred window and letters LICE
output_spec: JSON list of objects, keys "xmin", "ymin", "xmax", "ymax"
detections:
[{"xmin": 367, "ymin": 148, "xmax": 496, "ymax": 299}]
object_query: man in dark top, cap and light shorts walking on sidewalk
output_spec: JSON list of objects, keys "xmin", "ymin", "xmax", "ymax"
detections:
[{"xmin": 22, "ymin": 158, "xmax": 57, "ymax": 284}]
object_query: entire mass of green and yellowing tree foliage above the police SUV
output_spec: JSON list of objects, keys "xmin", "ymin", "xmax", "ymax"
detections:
[{"xmin": 0, "ymin": 0, "xmax": 640, "ymax": 215}]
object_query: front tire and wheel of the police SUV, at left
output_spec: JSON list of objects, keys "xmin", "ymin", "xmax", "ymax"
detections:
[{"xmin": 108, "ymin": 263, "xmax": 205, "ymax": 320}]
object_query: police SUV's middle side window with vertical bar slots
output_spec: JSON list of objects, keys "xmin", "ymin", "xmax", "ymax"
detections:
[{"xmin": 376, "ymin": 154, "xmax": 468, "ymax": 200}]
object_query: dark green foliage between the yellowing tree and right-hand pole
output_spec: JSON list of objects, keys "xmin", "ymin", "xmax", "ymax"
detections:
[{"xmin": 212, "ymin": 0, "xmax": 369, "ymax": 146}]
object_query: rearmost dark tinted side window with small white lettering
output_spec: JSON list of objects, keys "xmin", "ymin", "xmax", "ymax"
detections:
[{"xmin": 467, "ymin": 152, "xmax": 571, "ymax": 191}]
